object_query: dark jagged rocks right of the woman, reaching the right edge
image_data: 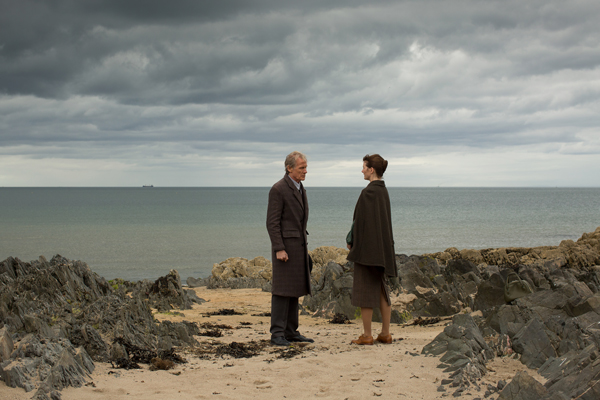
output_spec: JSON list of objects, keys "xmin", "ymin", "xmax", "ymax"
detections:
[{"xmin": 414, "ymin": 228, "xmax": 600, "ymax": 400}]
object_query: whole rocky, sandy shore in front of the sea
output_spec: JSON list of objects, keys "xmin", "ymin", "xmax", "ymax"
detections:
[{"xmin": 0, "ymin": 227, "xmax": 600, "ymax": 400}]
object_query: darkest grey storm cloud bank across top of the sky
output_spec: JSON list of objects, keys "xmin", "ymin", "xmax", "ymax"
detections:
[{"xmin": 0, "ymin": 0, "xmax": 600, "ymax": 103}]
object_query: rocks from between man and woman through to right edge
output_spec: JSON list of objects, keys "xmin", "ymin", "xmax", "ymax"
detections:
[{"xmin": 303, "ymin": 228, "xmax": 600, "ymax": 399}]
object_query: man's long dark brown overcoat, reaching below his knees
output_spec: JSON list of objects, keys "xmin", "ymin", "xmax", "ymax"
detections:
[{"xmin": 267, "ymin": 175, "xmax": 310, "ymax": 297}]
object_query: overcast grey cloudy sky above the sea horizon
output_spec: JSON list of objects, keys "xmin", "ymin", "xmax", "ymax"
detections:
[{"xmin": 0, "ymin": 0, "xmax": 600, "ymax": 187}]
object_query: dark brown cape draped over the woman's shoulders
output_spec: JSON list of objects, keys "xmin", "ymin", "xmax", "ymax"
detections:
[{"xmin": 347, "ymin": 180, "xmax": 398, "ymax": 277}]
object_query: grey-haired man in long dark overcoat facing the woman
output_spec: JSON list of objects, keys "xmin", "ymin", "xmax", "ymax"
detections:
[{"xmin": 267, "ymin": 151, "xmax": 314, "ymax": 346}]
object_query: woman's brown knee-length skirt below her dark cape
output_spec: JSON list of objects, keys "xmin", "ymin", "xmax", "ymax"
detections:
[{"xmin": 352, "ymin": 263, "xmax": 392, "ymax": 308}]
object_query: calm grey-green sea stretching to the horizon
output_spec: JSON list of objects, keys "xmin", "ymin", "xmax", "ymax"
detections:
[{"xmin": 0, "ymin": 186, "xmax": 600, "ymax": 282}]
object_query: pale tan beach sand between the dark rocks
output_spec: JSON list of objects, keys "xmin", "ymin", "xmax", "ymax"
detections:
[{"xmin": 0, "ymin": 288, "xmax": 544, "ymax": 400}]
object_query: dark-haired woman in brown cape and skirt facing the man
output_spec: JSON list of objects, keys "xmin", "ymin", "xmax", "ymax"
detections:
[{"xmin": 346, "ymin": 154, "xmax": 398, "ymax": 345}]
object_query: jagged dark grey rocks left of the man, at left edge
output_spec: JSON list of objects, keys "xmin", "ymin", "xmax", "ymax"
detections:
[{"xmin": 0, "ymin": 255, "xmax": 199, "ymax": 399}]
